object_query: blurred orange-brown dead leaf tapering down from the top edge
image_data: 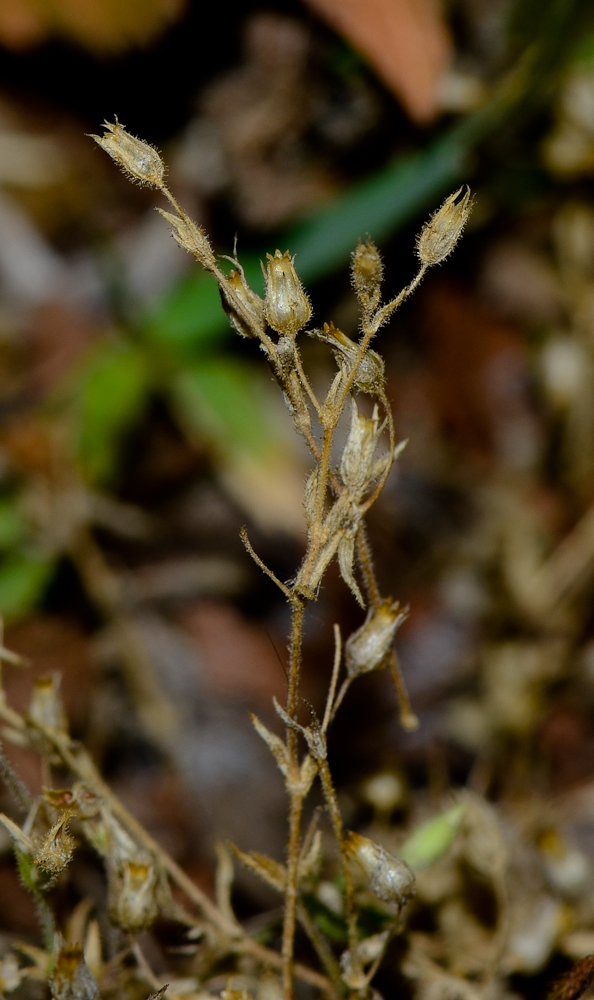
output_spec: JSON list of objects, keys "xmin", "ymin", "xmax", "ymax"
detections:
[{"xmin": 300, "ymin": 0, "xmax": 451, "ymax": 123}]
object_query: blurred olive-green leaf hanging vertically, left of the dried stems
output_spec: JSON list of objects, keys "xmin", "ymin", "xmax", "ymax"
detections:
[{"xmin": 74, "ymin": 340, "xmax": 152, "ymax": 484}]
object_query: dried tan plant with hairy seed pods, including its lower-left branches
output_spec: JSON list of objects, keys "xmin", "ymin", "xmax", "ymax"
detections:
[{"xmin": 0, "ymin": 121, "xmax": 471, "ymax": 1000}]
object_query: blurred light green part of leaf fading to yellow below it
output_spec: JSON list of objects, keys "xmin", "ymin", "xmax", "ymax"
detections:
[{"xmin": 173, "ymin": 358, "xmax": 279, "ymax": 459}]
